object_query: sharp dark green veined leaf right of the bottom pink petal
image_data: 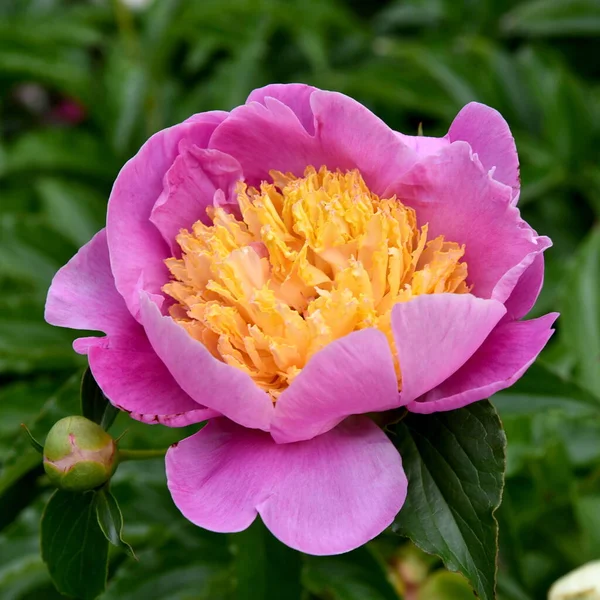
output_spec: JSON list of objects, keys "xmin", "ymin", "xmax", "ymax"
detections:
[{"xmin": 392, "ymin": 401, "xmax": 506, "ymax": 600}]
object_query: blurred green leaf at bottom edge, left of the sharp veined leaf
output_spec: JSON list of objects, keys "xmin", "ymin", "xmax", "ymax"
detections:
[{"xmin": 302, "ymin": 546, "xmax": 400, "ymax": 600}]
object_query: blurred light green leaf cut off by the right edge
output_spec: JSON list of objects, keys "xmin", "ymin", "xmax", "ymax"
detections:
[{"xmin": 561, "ymin": 227, "xmax": 600, "ymax": 397}]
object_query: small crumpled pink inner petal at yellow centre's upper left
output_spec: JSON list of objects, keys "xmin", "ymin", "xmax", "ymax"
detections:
[{"xmin": 150, "ymin": 145, "xmax": 243, "ymax": 254}]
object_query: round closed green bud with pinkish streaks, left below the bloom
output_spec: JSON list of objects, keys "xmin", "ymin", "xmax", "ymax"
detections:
[{"xmin": 44, "ymin": 416, "xmax": 118, "ymax": 492}]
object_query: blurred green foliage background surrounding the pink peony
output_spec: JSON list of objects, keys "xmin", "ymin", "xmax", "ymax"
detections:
[{"xmin": 0, "ymin": 0, "xmax": 600, "ymax": 600}]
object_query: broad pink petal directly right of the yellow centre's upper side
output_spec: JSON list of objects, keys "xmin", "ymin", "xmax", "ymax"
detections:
[{"xmin": 388, "ymin": 142, "xmax": 548, "ymax": 302}]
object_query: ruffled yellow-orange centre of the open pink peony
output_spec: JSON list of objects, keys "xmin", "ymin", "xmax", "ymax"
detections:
[{"xmin": 163, "ymin": 167, "xmax": 469, "ymax": 400}]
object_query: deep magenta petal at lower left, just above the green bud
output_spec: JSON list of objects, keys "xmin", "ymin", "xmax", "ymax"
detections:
[{"xmin": 88, "ymin": 332, "xmax": 218, "ymax": 427}]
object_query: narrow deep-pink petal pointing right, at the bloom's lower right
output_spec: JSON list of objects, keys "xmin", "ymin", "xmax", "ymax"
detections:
[{"xmin": 408, "ymin": 313, "xmax": 558, "ymax": 414}]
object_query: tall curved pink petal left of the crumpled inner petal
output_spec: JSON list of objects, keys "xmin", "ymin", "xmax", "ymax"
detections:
[{"xmin": 106, "ymin": 112, "xmax": 227, "ymax": 318}]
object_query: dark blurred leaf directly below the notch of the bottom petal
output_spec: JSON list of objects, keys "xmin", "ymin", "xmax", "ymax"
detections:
[{"xmin": 232, "ymin": 518, "xmax": 302, "ymax": 600}]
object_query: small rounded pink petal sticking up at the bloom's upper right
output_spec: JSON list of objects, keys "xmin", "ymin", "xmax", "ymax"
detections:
[{"xmin": 448, "ymin": 102, "xmax": 520, "ymax": 194}]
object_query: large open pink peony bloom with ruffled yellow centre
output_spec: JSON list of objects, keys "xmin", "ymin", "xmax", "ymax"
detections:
[{"xmin": 46, "ymin": 85, "xmax": 556, "ymax": 554}]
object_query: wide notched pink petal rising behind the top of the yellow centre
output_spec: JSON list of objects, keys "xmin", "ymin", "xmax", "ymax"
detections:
[{"xmin": 210, "ymin": 86, "xmax": 416, "ymax": 193}]
